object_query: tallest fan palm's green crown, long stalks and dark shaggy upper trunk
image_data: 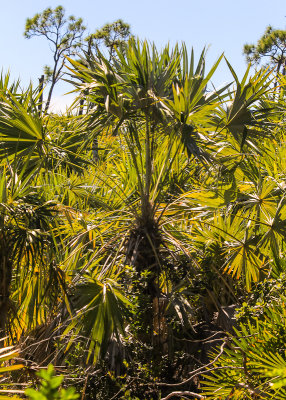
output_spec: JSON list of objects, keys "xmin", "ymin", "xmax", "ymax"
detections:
[{"xmin": 68, "ymin": 39, "xmax": 222, "ymax": 276}]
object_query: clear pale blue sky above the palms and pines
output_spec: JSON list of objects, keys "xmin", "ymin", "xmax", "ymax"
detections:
[{"xmin": 0, "ymin": 0, "xmax": 286, "ymax": 110}]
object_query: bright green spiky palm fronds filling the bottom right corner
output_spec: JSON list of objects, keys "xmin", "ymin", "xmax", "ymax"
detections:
[{"xmin": 203, "ymin": 290, "xmax": 286, "ymax": 400}]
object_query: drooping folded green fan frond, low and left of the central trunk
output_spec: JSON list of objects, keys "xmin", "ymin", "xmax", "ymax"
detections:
[{"xmin": 63, "ymin": 272, "xmax": 132, "ymax": 362}]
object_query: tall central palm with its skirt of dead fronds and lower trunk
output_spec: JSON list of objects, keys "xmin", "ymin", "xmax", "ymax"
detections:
[{"xmin": 65, "ymin": 39, "xmax": 237, "ymax": 360}]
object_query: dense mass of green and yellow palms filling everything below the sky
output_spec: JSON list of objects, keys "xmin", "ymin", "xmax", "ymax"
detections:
[{"xmin": 0, "ymin": 38, "xmax": 286, "ymax": 400}]
